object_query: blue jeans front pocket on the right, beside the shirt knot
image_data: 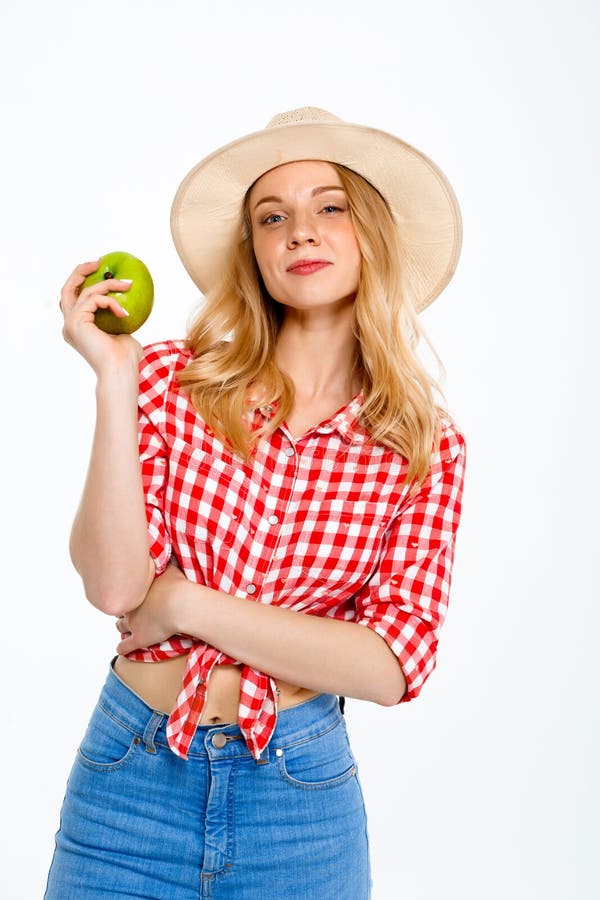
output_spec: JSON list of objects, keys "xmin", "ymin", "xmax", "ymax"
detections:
[{"xmin": 275, "ymin": 719, "xmax": 356, "ymax": 790}]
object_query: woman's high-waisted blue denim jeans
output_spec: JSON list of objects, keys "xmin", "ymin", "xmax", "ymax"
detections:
[{"xmin": 45, "ymin": 666, "xmax": 370, "ymax": 900}]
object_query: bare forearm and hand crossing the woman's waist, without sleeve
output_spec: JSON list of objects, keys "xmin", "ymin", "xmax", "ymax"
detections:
[{"xmin": 117, "ymin": 565, "xmax": 405, "ymax": 706}]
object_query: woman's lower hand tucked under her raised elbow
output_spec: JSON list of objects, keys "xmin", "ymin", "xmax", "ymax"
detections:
[{"xmin": 116, "ymin": 563, "xmax": 189, "ymax": 656}]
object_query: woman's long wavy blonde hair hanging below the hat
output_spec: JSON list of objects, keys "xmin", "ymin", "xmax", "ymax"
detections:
[{"xmin": 179, "ymin": 163, "xmax": 444, "ymax": 488}]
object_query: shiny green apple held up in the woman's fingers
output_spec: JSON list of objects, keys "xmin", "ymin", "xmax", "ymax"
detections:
[{"xmin": 82, "ymin": 250, "xmax": 154, "ymax": 334}]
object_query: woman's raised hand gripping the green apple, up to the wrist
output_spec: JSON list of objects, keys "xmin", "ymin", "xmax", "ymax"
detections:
[{"xmin": 60, "ymin": 260, "xmax": 142, "ymax": 376}]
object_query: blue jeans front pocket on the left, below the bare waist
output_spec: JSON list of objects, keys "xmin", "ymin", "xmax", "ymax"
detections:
[{"xmin": 77, "ymin": 703, "xmax": 141, "ymax": 773}]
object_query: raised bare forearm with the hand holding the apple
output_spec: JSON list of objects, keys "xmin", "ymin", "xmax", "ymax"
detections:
[{"xmin": 61, "ymin": 263, "xmax": 155, "ymax": 615}]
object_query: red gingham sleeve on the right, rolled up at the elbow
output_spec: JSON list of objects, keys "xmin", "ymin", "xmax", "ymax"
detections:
[{"xmin": 355, "ymin": 425, "xmax": 466, "ymax": 702}]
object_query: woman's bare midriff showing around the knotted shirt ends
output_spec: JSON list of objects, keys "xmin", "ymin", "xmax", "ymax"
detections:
[{"xmin": 115, "ymin": 655, "xmax": 318, "ymax": 725}]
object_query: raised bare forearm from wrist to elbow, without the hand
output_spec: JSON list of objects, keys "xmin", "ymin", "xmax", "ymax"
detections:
[{"xmin": 70, "ymin": 363, "xmax": 154, "ymax": 615}]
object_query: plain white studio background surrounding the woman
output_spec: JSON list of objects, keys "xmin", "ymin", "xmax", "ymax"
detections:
[{"xmin": 0, "ymin": 0, "xmax": 600, "ymax": 900}]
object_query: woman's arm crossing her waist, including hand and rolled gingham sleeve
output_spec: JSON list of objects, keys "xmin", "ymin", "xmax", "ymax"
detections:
[{"xmin": 117, "ymin": 426, "xmax": 466, "ymax": 705}]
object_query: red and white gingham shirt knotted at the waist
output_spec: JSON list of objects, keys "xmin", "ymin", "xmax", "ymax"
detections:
[{"xmin": 128, "ymin": 341, "xmax": 465, "ymax": 759}]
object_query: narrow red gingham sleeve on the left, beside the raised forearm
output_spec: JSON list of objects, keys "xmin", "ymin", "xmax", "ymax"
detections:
[{"xmin": 138, "ymin": 344, "xmax": 173, "ymax": 575}]
